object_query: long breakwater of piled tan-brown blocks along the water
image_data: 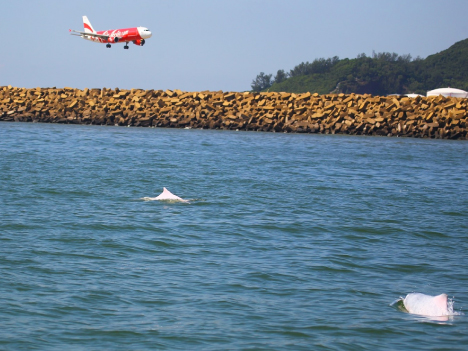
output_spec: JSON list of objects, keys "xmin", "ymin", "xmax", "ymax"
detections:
[{"xmin": 0, "ymin": 86, "xmax": 468, "ymax": 140}]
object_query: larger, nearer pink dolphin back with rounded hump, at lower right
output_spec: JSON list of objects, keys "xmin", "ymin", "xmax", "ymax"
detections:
[{"xmin": 402, "ymin": 293, "xmax": 454, "ymax": 317}]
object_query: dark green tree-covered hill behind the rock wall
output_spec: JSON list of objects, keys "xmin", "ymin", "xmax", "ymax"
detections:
[{"xmin": 251, "ymin": 39, "xmax": 468, "ymax": 95}]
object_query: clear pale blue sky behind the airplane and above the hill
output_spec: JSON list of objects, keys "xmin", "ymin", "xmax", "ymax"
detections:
[{"xmin": 0, "ymin": 0, "xmax": 468, "ymax": 91}]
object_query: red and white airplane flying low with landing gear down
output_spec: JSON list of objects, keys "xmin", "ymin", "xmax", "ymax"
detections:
[{"xmin": 69, "ymin": 16, "xmax": 152, "ymax": 49}]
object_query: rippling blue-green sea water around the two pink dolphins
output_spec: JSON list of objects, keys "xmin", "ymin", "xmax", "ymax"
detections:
[{"xmin": 0, "ymin": 122, "xmax": 468, "ymax": 350}]
